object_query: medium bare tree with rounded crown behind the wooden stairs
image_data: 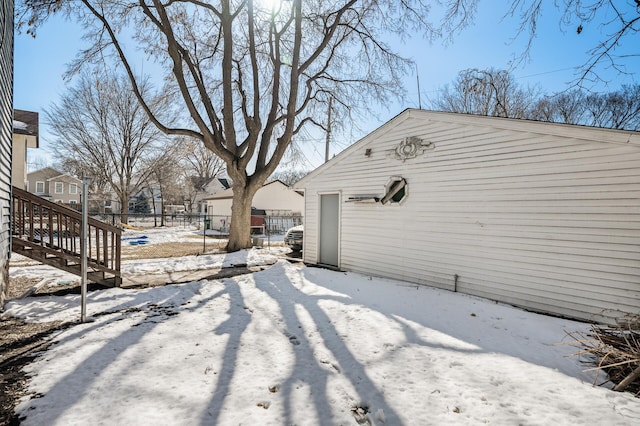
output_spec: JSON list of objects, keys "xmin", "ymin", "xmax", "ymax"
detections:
[{"xmin": 45, "ymin": 73, "xmax": 169, "ymax": 223}]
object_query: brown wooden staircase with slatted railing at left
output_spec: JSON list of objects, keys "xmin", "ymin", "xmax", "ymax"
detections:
[{"xmin": 11, "ymin": 186, "xmax": 122, "ymax": 287}]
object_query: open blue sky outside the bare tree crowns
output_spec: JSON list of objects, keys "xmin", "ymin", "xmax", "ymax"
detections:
[{"xmin": 14, "ymin": 2, "xmax": 640, "ymax": 169}]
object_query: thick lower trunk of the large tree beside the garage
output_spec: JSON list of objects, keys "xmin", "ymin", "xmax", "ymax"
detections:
[{"xmin": 227, "ymin": 182, "xmax": 260, "ymax": 252}]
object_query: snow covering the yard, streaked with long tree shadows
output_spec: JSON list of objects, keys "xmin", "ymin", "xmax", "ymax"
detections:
[{"xmin": 4, "ymin": 228, "xmax": 640, "ymax": 425}]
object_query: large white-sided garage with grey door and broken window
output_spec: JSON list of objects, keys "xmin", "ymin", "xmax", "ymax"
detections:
[{"xmin": 296, "ymin": 110, "xmax": 640, "ymax": 322}]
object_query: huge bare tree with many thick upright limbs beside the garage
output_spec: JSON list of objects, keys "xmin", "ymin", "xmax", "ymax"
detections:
[{"xmin": 18, "ymin": 0, "xmax": 476, "ymax": 251}]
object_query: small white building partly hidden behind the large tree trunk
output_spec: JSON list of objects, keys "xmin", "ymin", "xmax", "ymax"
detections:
[{"xmin": 205, "ymin": 180, "xmax": 304, "ymax": 229}]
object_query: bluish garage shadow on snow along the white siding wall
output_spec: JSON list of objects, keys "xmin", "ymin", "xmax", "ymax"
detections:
[{"xmin": 300, "ymin": 267, "xmax": 593, "ymax": 381}]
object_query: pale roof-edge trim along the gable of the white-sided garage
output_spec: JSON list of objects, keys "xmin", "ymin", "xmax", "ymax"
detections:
[{"xmin": 294, "ymin": 108, "xmax": 640, "ymax": 189}]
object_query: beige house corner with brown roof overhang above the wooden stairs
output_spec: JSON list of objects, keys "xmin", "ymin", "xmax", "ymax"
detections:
[{"xmin": 11, "ymin": 109, "xmax": 39, "ymax": 189}]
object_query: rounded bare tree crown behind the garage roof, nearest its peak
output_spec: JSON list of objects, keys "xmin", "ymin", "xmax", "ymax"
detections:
[{"xmin": 434, "ymin": 68, "xmax": 536, "ymax": 118}]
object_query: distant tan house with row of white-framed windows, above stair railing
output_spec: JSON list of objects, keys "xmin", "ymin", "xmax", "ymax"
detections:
[{"xmin": 27, "ymin": 167, "xmax": 82, "ymax": 205}]
